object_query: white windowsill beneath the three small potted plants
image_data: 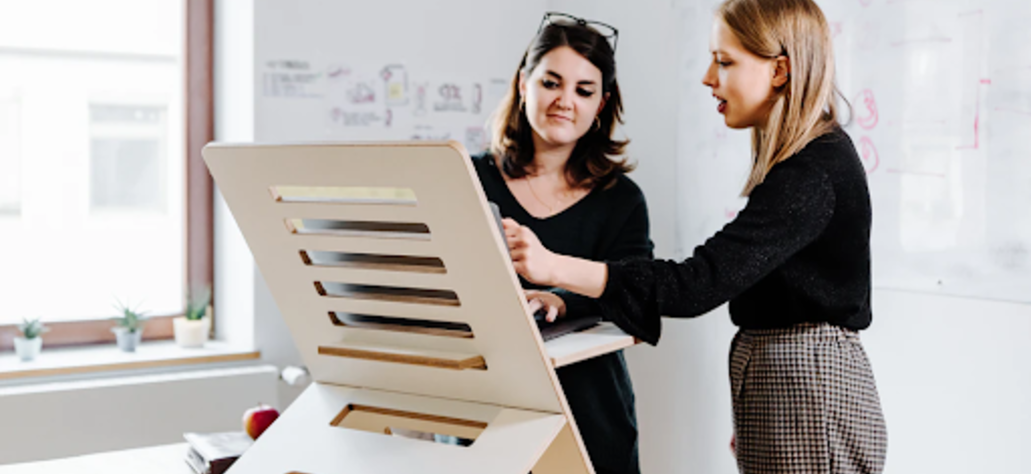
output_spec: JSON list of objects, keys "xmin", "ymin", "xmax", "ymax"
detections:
[{"xmin": 0, "ymin": 341, "xmax": 261, "ymax": 382}]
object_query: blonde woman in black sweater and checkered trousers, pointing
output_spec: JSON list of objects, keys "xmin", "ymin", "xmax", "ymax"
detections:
[{"xmin": 505, "ymin": 0, "xmax": 887, "ymax": 473}]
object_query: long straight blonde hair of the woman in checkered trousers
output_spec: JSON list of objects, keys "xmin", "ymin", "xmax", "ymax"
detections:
[{"xmin": 717, "ymin": 0, "xmax": 837, "ymax": 196}]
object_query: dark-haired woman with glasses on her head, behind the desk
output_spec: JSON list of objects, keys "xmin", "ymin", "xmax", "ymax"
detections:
[{"xmin": 473, "ymin": 13, "xmax": 652, "ymax": 474}]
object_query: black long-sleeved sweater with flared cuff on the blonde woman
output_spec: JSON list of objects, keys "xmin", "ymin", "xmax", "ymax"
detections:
[{"xmin": 599, "ymin": 129, "xmax": 871, "ymax": 344}]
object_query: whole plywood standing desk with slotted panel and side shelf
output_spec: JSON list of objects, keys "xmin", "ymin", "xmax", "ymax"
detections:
[{"xmin": 204, "ymin": 142, "xmax": 633, "ymax": 474}]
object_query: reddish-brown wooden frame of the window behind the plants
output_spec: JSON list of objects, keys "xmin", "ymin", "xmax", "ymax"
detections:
[{"xmin": 0, "ymin": 0, "xmax": 214, "ymax": 351}]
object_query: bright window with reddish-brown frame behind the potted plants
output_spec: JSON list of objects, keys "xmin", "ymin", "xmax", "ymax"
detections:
[{"xmin": 0, "ymin": 0, "xmax": 213, "ymax": 350}]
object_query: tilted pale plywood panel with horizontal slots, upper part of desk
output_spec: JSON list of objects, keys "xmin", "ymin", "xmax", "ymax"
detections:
[{"xmin": 204, "ymin": 142, "xmax": 566, "ymax": 413}]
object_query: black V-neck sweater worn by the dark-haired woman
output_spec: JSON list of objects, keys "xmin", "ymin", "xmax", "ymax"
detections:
[{"xmin": 472, "ymin": 156, "xmax": 653, "ymax": 474}]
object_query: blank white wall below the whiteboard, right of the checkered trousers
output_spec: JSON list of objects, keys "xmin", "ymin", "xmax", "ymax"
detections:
[{"xmin": 863, "ymin": 290, "xmax": 1031, "ymax": 473}]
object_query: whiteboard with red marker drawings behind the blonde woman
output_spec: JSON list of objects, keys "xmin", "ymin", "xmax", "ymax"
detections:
[{"xmin": 677, "ymin": 0, "xmax": 1031, "ymax": 302}]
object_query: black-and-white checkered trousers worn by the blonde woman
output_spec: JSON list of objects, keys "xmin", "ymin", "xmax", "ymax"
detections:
[{"xmin": 730, "ymin": 323, "xmax": 888, "ymax": 474}]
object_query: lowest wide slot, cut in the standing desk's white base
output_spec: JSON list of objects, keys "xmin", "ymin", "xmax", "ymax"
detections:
[{"xmin": 330, "ymin": 404, "xmax": 488, "ymax": 446}]
